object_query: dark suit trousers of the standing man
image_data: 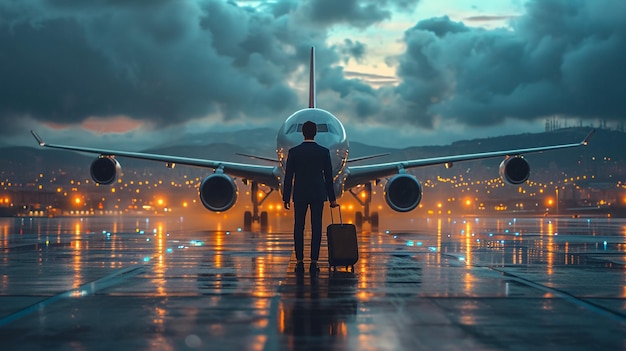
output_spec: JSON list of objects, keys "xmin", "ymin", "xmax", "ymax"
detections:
[{"xmin": 293, "ymin": 201, "xmax": 324, "ymax": 261}]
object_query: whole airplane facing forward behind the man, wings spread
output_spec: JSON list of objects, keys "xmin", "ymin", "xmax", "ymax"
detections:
[{"xmin": 32, "ymin": 48, "xmax": 593, "ymax": 228}]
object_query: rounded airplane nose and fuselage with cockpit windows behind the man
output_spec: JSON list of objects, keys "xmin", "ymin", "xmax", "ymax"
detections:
[{"xmin": 276, "ymin": 108, "xmax": 349, "ymax": 196}]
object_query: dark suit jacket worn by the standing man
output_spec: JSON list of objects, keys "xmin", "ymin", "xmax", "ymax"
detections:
[{"xmin": 283, "ymin": 141, "xmax": 336, "ymax": 202}]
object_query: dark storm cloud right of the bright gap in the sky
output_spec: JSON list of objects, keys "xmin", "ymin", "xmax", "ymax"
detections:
[{"xmin": 394, "ymin": 0, "xmax": 626, "ymax": 127}]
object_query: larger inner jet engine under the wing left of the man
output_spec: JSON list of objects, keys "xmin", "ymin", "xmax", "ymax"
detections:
[{"xmin": 200, "ymin": 173, "xmax": 237, "ymax": 212}]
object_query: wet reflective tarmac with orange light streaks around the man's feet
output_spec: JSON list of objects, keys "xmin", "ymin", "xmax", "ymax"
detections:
[{"xmin": 0, "ymin": 217, "xmax": 626, "ymax": 351}]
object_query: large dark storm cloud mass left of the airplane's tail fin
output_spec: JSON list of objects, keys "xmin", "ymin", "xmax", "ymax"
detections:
[{"xmin": 0, "ymin": 0, "xmax": 308, "ymax": 135}]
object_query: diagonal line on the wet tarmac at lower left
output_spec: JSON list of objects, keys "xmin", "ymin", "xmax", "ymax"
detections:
[{"xmin": 0, "ymin": 265, "xmax": 144, "ymax": 327}]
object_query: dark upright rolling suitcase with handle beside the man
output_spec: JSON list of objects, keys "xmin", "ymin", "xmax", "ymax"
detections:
[{"xmin": 326, "ymin": 208, "xmax": 359, "ymax": 272}]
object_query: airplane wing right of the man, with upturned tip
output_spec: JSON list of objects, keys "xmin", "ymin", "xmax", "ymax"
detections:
[{"xmin": 344, "ymin": 129, "xmax": 595, "ymax": 189}]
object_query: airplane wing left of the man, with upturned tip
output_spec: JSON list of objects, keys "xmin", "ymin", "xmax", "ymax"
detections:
[{"xmin": 31, "ymin": 130, "xmax": 280, "ymax": 189}]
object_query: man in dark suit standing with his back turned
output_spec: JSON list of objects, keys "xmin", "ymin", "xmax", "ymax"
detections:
[{"xmin": 283, "ymin": 121, "xmax": 338, "ymax": 273}]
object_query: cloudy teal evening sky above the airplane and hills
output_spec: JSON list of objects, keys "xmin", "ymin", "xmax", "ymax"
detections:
[{"xmin": 0, "ymin": 0, "xmax": 626, "ymax": 150}]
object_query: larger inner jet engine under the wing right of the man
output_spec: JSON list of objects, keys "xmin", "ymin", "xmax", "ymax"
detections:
[{"xmin": 385, "ymin": 174, "xmax": 422, "ymax": 212}]
